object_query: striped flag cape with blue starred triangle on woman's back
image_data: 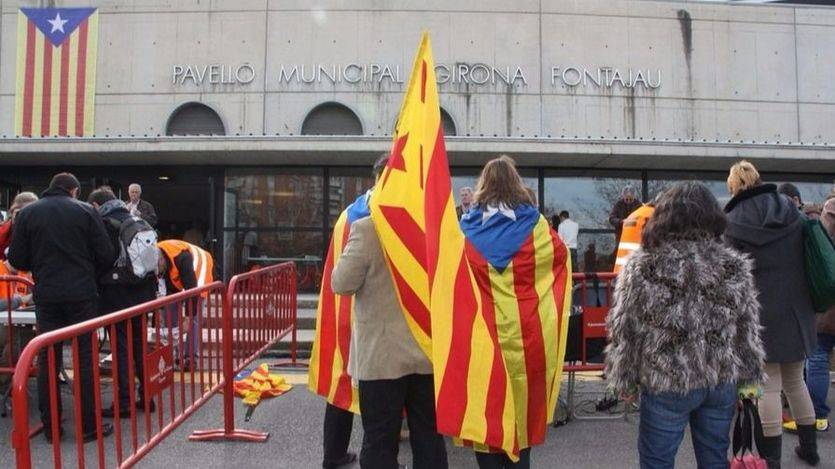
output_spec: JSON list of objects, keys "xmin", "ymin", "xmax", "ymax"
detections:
[{"xmin": 452, "ymin": 205, "xmax": 571, "ymax": 450}]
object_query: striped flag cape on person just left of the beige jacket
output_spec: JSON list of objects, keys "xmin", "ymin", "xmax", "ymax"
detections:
[{"xmin": 308, "ymin": 191, "xmax": 371, "ymax": 413}]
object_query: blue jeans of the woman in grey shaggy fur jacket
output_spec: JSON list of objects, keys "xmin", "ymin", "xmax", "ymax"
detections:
[{"xmin": 638, "ymin": 383, "xmax": 737, "ymax": 469}]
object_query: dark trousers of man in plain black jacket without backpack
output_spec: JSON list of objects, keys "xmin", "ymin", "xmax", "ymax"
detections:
[{"xmin": 35, "ymin": 300, "xmax": 96, "ymax": 432}]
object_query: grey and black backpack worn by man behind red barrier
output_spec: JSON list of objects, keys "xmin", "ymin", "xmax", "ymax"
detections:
[{"xmin": 104, "ymin": 215, "xmax": 159, "ymax": 285}]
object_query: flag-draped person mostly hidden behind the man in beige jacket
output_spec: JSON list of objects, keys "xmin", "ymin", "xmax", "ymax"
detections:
[{"xmin": 308, "ymin": 153, "xmax": 389, "ymax": 469}]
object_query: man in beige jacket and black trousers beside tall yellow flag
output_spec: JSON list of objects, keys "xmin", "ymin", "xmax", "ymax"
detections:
[{"xmin": 331, "ymin": 157, "xmax": 447, "ymax": 469}]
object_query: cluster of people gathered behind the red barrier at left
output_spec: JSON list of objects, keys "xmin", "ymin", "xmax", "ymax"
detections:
[{"xmin": 0, "ymin": 173, "xmax": 214, "ymax": 442}]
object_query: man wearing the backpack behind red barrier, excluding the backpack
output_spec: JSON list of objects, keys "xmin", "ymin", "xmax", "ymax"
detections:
[{"xmin": 87, "ymin": 188, "xmax": 157, "ymax": 418}]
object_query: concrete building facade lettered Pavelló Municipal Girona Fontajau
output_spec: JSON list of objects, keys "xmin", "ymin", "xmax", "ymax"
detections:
[{"xmin": 0, "ymin": 0, "xmax": 835, "ymax": 288}]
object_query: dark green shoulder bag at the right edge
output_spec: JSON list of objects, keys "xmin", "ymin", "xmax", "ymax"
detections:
[{"xmin": 803, "ymin": 220, "xmax": 835, "ymax": 313}]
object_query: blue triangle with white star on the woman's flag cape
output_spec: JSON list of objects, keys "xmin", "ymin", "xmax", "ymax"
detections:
[{"xmin": 461, "ymin": 205, "xmax": 539, "ymax": 272}]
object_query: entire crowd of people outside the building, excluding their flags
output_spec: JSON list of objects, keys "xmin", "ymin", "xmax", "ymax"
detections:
[{"xmin": 0, "ymin": 156, "xmax": 835, "ymax": 469}]
